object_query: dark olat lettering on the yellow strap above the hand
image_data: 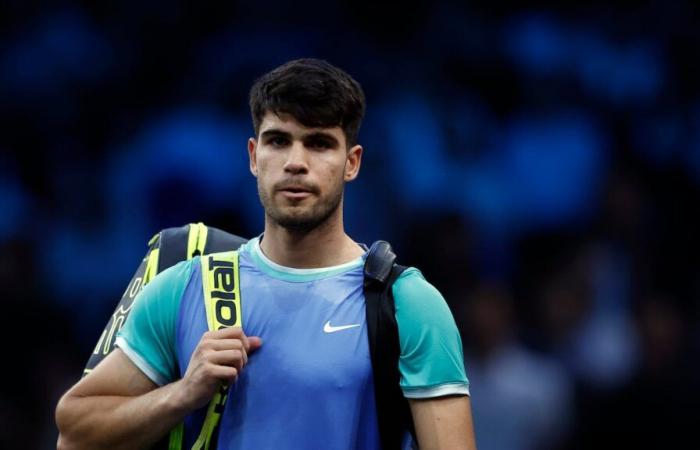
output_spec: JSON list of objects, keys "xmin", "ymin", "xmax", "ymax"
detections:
[{"xmin": 208, "ymin": 256, "xmax": 239, "ymax": 330}]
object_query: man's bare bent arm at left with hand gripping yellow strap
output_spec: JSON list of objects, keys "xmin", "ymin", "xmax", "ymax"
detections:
[{"xmin": 56, "ymin": 328, "xmax": 261, "ymax": 450}]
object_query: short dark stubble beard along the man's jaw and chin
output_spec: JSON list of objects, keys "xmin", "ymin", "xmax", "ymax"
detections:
[{"xmin": 258, "ymin": 180, "xmax": 344, "ymax": 234}]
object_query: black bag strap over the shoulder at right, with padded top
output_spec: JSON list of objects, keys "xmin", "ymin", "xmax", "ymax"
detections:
[{"xmin": 364, "ymin": 241, "xmax": 415, "ymax": 450}]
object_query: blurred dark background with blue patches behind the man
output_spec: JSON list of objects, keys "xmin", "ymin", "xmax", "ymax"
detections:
[{"xmin": 0, "ymin": 0, "xmax": 700, "ymax": 450}]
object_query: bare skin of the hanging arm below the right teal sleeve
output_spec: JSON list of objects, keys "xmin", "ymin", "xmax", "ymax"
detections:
[{"xmin": 409, "ymin": 395, "xmax": 476, "ymax": 450}]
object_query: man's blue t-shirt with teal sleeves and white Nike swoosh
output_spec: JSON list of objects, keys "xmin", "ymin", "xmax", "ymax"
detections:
[{"xmin": 117, "ymin": 238, "xmax": 469, "ymax": 450}]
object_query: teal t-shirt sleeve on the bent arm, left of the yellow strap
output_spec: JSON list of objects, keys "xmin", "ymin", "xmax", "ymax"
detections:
[{"xmin": 117, "ymin": 258, "xmax": 199, "ymax": 386}]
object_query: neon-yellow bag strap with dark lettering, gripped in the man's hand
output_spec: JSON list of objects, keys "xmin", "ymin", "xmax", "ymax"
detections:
[{"xmin": 192, "ymin": 251, "xmax": 242, "ymax": 450}]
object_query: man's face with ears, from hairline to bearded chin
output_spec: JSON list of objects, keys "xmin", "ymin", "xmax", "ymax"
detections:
[{"xmin": 248, "ymin": 112, "xmax": 362, "ymax": 232}]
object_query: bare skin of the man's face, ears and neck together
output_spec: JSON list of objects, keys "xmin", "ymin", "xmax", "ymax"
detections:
[{"xmin": 248, "ymin": 112, "xmax": 364, "ymax": 268}]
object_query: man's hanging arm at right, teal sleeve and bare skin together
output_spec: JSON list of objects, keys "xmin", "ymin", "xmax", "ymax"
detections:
[{"xmin": 393, "ymin": 269, "xmax": 476, "ymax": 450}]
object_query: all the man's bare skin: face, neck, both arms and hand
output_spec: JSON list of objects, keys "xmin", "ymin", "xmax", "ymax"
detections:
[{"xmin": 56, "ymin": 112, "xmax": 476, "ymax": 449}]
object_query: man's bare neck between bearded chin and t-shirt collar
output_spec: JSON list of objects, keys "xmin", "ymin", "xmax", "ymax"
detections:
[{"xmin": 260, "ymin": 211, "xmax": 364, "ymax": 269}]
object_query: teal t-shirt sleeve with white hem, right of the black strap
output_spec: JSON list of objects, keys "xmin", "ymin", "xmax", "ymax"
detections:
[{"xmin": 392, "ymin": 268, "xmax": 469, "ymax": 398}]
